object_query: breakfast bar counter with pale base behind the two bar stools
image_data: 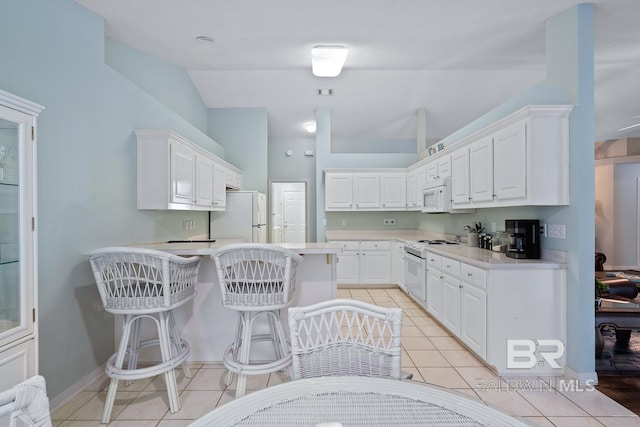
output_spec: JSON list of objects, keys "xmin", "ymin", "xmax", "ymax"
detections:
[{"xmin": 127, "ymin": 239, "xmax": 342, "ymax": 362}]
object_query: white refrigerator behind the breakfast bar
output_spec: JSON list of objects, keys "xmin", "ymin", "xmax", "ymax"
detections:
[{"xmin": 209, "ymin": 191, "xmax": 267, "ymax": 243}]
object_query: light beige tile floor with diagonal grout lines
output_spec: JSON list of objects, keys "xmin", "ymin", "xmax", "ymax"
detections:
[{"xmin": 52, "ymin": 288, "xmax": 640, "ymax": 427}]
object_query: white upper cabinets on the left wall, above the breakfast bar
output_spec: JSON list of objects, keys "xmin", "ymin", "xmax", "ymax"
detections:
[{"xmin": 136, "ymin": 130, "xmax": 241, "ymax": 211}]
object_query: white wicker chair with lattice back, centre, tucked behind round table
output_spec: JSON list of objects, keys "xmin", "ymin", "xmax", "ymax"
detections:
[{"xmin": 289, "ymin": 299, "xmax": 403, "ymax": 379}]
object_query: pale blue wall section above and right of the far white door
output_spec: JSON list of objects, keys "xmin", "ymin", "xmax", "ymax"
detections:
[{"xmin": 268, "ymin": 138, "xmax": 317, "ymax": 242}]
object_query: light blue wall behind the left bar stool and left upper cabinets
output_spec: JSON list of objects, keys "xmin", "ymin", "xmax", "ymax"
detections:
[{"xmin": 0, "ymin": 0, "xmax": 229, "ymax": 397}]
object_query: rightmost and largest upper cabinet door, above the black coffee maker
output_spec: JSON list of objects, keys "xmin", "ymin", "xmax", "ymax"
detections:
[{"xmin": 493, "ymin": 122, "xmax": 527, "ymax": 200}]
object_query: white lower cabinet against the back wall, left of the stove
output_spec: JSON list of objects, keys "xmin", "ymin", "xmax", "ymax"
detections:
[{"xmin": 332, "ymin": 240, "xmax": 391, "ymax": 285}]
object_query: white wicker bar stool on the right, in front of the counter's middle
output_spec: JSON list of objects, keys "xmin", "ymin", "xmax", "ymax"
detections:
[{"xmin": 211, "ymin": 243, "xmax": 302, "ymax": 397}]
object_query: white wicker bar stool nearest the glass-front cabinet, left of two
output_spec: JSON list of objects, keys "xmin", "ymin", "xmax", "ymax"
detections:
[{"xmin": 89, "ymin": 247, "xmax": 201, "ymax": 424}]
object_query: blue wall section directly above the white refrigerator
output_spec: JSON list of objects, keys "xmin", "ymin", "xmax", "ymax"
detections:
[{"xmin": 208, "ymin": 108, "xmax": 268, "ymax": 194}]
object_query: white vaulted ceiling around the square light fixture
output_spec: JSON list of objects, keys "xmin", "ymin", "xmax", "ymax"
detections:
[{"xmin": 76, "ymin": 0, "xmax": 640, "ymax": 144}]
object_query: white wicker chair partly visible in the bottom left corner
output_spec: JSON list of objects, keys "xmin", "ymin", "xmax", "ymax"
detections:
[{"xmin": 0, "ymin": 375, "xmax": 51, "ymax": 427}]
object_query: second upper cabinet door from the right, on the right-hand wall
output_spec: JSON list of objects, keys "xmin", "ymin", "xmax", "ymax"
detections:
[{"xmin": 469, "ymin": 137, "xmax": 493, "ymax": 202}]
